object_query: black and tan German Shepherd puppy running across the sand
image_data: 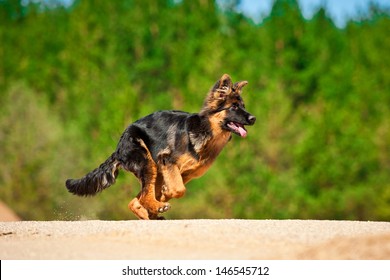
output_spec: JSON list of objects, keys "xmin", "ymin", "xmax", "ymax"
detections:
[{"xmin": 66, "ymin": 74, "xmax": 256, "ymax": 220}]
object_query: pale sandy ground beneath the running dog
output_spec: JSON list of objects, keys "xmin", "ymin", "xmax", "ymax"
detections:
[{"xmin": 0, "ymin": 220, "xmax": 390, "ymax": 260}]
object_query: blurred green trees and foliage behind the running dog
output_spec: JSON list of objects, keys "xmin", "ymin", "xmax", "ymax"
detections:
[{"xmin": 0, "ymin": 0, "xmax": 390, "ymax": 221}]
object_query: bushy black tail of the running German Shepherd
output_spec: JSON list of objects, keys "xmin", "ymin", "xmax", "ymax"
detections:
[{"xmin": 66, "ymin": 153, "xmax": 120, "ymax": 196}]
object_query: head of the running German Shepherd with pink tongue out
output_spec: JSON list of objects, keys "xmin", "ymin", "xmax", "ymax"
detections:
[{"xmin": 201, "ymin": 74, "xmax": 256, "ymax": 137}]
